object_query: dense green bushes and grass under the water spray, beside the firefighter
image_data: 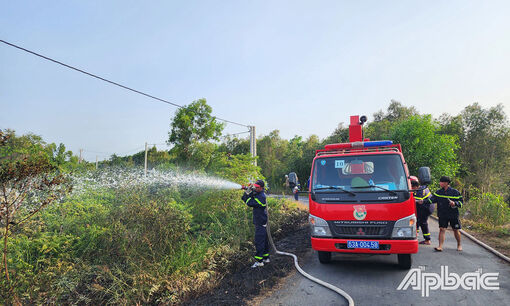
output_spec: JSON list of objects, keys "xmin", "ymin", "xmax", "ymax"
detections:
[{"xmin": 4, "ymin": 177, "xmax": 297, "ymax": 304}]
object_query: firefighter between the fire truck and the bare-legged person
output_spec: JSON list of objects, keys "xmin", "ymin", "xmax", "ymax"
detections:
[{"xmin": 410, "ymin": 176, "xmax": 434, "ymax": 245}]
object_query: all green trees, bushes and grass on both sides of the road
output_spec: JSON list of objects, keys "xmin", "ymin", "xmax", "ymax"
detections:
[{"xmin": 0, "ymin": 99, "xmax": 510, "ymax": 304}]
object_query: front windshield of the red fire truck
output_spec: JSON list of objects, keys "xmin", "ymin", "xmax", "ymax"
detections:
[{"xmin": 311, "ymin": 154, "xmax": 408, "ymax": 192}]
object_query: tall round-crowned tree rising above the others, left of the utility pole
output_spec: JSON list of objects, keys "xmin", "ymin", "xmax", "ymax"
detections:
[{"xmin": 167, "ymin": 99, "xmax": 224, "ymax": 163}]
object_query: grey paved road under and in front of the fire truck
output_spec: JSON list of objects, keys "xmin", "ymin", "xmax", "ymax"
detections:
[{"xmin": 261, "ymin": 198, "xmax": 510, "ymax": 306}]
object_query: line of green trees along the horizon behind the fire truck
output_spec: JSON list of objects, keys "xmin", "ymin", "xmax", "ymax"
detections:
[{"xmin": 3, "ymin": 99, "xmax": 510, "ymax": 202}]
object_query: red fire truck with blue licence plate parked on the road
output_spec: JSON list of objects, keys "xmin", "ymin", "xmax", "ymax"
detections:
[{"xmin": 309, "ymin": 116, "xmax": 430, "ymax": 269}]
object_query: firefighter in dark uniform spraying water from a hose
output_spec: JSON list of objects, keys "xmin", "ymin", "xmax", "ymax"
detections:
[{"xmin": 242, "ymin": 180, "xmax": 270, "ymax": 268}]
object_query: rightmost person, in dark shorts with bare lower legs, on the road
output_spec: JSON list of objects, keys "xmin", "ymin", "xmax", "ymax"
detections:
[{"xmin": 424, "ymin": 176, "xmax": 463, "ymax": 252}]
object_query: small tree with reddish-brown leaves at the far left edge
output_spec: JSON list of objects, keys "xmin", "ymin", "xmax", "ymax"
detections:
[{"xmin": 0, "ymin": 130, "xmax": 71, "ymax": 296}]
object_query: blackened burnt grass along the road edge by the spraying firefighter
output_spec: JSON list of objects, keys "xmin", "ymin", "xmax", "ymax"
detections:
[{"xmin": 183, "ymin": 213, "xmax": 311, "ymax": 305}]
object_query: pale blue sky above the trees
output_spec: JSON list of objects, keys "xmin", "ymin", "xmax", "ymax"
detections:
[{"xmin": 0, "ymin": 0, "xmax": 510, "ymax": 161}]
